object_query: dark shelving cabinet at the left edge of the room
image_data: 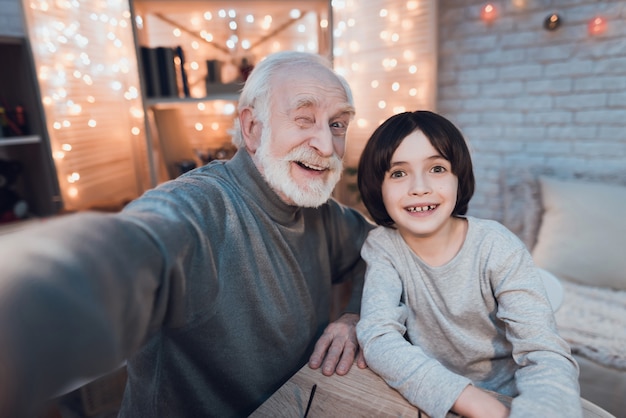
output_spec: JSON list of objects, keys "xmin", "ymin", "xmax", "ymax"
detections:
[{"xmin": 0, "ymin": 36, "xmax": 61, "ymax": 216}]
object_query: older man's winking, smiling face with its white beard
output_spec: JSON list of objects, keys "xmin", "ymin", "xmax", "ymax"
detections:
[{"xmin": 254, "ymin": 66, "xmax": 354, "ymax": 207}]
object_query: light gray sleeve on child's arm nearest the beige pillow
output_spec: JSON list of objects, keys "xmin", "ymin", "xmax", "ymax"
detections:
[{"xmin": 491, "ymin": 248, "xmax": 582, "ymax": 417}]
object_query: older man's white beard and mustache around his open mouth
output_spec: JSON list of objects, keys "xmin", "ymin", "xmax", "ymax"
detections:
[{"xmin": 255, "ymin": 124, "xmax": 343, "ymax": 208}]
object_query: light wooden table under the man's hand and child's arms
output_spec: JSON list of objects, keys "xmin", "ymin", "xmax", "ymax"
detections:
[{"xmin": 250, "ymin": 364, "xmax": 615, "ymax": 418}]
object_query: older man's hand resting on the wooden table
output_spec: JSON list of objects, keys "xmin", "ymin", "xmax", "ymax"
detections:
[{"xmin": 309, "ymin": 314, "xmax": 367, "ymax": 376}]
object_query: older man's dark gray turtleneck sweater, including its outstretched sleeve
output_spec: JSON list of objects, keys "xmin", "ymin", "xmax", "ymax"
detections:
[{"xmin": 0, "ymin": 151, "xmax": 372, "ymax": 417}]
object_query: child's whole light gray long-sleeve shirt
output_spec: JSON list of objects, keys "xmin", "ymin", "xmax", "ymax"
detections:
[{"xmin": 357, "ymin": 217, "xmax": 582, "ymax": 418}]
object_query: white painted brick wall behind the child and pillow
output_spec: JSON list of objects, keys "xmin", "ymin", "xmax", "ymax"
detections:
[{"xmin": 437, "ymin": 0, "xmax": 626, "ymax": 220}]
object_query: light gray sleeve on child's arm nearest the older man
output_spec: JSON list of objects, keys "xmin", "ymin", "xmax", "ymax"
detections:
[{"xmin": 357, "ymin": 234, "xmax": 471, "ymax": 418}]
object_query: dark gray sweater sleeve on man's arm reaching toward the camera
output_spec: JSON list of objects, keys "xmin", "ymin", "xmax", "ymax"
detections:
[{"xmin": 0, "ymin": 213, "xmax": 182, "ymax": 417}]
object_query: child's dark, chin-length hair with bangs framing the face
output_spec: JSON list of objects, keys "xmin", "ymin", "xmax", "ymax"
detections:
[{"xmin": 358, "ymin": 110, "xmax": 475, "ymax": 227}]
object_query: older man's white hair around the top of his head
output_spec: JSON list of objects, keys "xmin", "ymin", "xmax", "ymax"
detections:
[{"xmin": 232, "ymin": 51, "xmax": 354, "ymax": 148}]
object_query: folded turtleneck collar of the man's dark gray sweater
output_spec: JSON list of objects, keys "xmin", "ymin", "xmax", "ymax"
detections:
[{"xmin": 227, "ymin": 148, "xmax": 301, "ymax": 224}]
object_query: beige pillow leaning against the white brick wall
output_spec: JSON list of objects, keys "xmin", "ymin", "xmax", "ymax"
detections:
[{"xmin": 532, "ymin": 177, "xmax": 626, "ymax": 290}]
